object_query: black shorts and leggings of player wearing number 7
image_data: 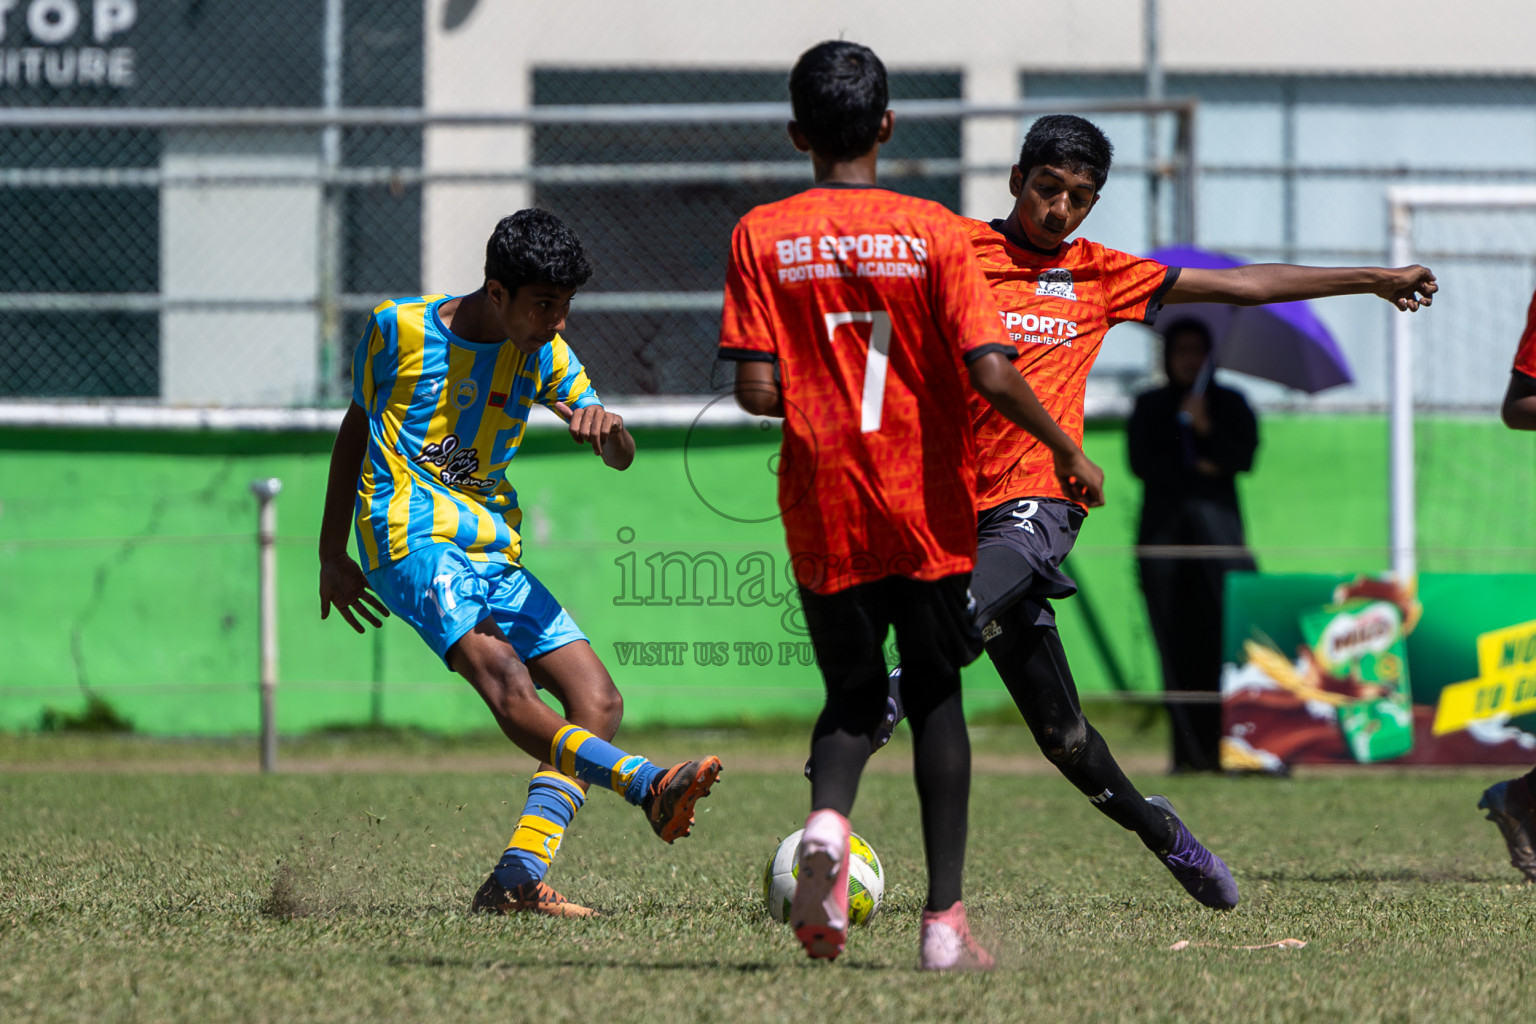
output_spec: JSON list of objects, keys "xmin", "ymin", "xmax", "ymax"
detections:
[{"xmin": 800, "ymin": 576, "xmax": 980, "ymax": 910}]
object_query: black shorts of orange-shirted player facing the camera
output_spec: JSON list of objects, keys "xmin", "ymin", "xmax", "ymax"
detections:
[{"xmin": 971, "ymin": 497, "xmax": 1086, "ymax": 634}]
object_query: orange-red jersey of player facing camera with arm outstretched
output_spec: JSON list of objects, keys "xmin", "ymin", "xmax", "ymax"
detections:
[{"xmin": 965, "ymin": 220, "xmax": 1178, "ymax": 510}]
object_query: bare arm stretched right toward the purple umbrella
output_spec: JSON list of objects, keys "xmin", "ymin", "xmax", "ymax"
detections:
[{"xmin": 1163, "ymin": 263, "xmax": 1439, "ymax": 313}]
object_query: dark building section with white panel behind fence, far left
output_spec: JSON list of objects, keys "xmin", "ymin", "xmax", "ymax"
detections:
[{"xmin": 0, "ymin": 0, "xmax": 422, "ymax": 405}]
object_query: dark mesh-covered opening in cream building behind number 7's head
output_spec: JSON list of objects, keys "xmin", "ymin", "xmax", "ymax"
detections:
[{"xmin": 533, "ymin": 69, "xmax": 960, "ymax": 395}]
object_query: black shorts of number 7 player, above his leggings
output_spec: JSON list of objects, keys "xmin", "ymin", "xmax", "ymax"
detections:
[{"xmin": 800, "ymin": 573, "xmax": 982, "ymax": 689}]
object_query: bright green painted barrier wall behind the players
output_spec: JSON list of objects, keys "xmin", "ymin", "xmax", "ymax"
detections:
[{"xmin": 0, "ymin": 416, "xmax": 1536, "ymax": 734}]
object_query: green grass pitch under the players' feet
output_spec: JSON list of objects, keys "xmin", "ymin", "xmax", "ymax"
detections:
[{"xmin": 0, "ymin": 729, "xmax": 1536, "ymax": 1024}]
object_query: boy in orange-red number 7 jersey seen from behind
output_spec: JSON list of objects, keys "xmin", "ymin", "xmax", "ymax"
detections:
[{"xmin": 720, "ymin": 41, "xmax": 1098, "ymax": 970}]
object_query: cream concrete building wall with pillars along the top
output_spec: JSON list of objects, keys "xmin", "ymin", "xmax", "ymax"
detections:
[{"xmin": 422, "ymin": 0, "xmax": 1536, "ymax": 289}]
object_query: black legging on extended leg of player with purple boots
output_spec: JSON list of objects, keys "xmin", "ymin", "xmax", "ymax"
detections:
[{"xmin": 983, "ymin": 599, "xmax": 1174, "ymax": 854}]
